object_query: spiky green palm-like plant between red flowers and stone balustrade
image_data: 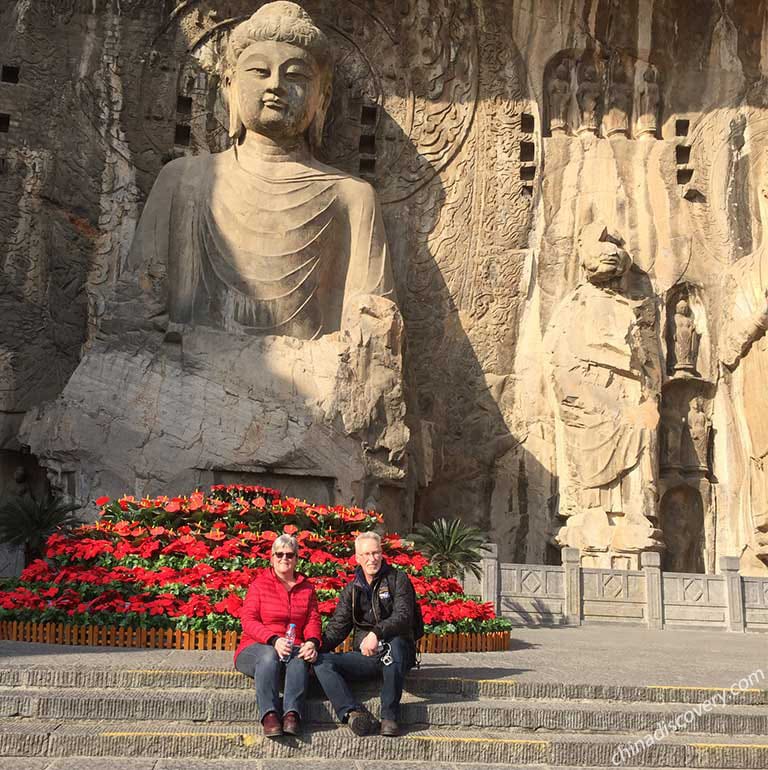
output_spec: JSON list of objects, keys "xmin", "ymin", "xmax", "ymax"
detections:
[{"xmin": 410, "ymin": 519, "xmax": 487, "ymax": 578}]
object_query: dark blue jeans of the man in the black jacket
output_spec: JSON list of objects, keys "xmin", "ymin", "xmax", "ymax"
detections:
[{"xmin": 314, "ymin": 636, "xmax": 415, "ymax": 722}]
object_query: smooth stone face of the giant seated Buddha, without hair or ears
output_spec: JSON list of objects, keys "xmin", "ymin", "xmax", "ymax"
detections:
[{"xmin": 235, "ymin": 40, "xmax": 323, "ymax": 138}]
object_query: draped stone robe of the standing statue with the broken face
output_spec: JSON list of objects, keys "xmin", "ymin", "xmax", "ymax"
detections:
[{"xmin": 545, "ymin": 283, "xmax": 658, "ymax": 515}]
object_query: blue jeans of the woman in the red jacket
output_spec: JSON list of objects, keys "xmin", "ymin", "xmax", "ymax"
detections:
[{"xmin": 235, "ymin": 643, "xmax": 309, "ymax": 720}]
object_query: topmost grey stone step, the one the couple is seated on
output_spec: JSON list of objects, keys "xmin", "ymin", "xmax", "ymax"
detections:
[{"xmin": 0, "ymin": 666, "xmax": 768, "ymax": 706}]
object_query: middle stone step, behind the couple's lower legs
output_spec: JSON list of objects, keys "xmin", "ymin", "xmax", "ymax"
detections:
[{"xmin": 0, "ymin": 687, "xmax": 768, "ymax": 735}]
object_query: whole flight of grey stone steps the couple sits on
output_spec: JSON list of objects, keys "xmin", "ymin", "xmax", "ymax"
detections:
[{"xmin": 0, "ymin": 666, "xmax": 768, "ymax": 770}]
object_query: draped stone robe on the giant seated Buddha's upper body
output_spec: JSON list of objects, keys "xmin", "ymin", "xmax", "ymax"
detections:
[{"xmin": 112, "ymin": 149, "xmax": 394, "ymax": 339}]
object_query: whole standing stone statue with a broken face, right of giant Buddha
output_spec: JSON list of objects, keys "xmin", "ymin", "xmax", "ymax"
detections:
[{"xmin": 545, "ymin": 224, "xmax": 663, "ymax": 567}]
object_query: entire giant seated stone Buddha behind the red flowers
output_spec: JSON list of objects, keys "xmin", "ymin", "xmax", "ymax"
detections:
[{"xmin": 21, "ymin": 1, "xmax": 415, "ymax": 528}]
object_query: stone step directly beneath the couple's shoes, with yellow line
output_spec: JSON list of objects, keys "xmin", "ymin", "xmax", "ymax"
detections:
[{"xmin": 0, "ymin": 718, "xmax": 768, "ymax": 770}]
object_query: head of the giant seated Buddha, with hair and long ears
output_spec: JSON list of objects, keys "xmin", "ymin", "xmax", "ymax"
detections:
[{"xmin": 225, "ymin": 0, "xmax": 333, "ymax": 149}]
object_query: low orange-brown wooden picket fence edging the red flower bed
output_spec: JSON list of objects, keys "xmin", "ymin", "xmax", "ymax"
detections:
[{"xmin": 0, "ymin": 620, "xmax": 510, "ymax": 652}]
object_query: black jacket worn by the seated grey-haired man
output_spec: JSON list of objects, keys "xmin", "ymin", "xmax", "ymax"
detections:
[{"xmin": 322, "ymin": 562, "xmax": 416, "ymax": 650}]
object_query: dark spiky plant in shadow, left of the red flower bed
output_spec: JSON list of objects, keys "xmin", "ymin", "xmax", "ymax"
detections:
[{"xmin": 0, "ymin": 495, "xmax": 84, "ymax": 564}]
